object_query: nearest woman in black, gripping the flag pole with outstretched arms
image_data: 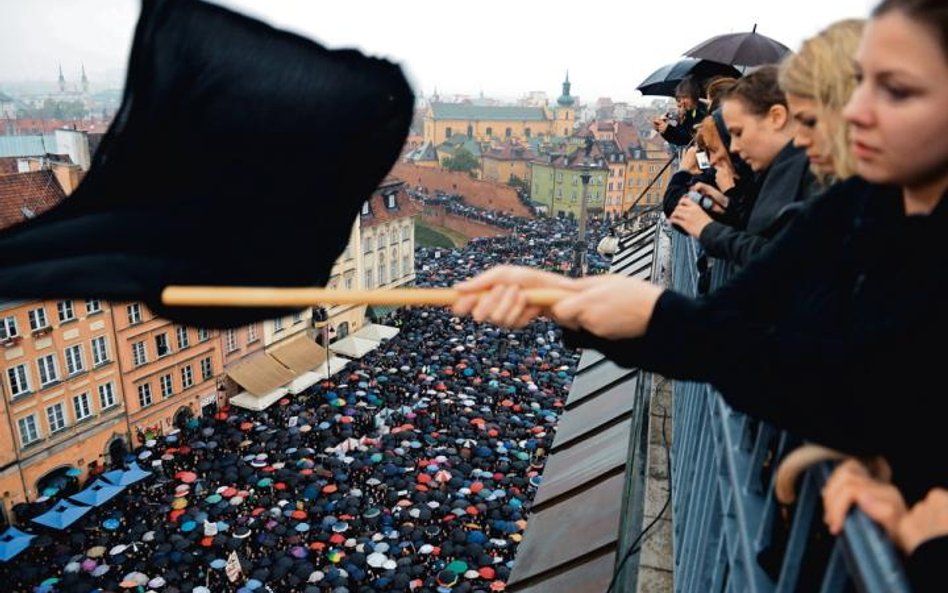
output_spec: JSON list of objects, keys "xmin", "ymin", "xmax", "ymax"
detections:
[{"xmin": 454, "ymin": 0, "xmax": 948, "ymax": 560}]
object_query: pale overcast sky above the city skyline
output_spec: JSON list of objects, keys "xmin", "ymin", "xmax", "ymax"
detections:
[{"xmin": 0, "ymin": 0, "xmax": 875, "ymax": 101}]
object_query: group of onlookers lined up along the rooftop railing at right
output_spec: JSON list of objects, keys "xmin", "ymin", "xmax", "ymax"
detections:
[{"xmin": 454, "ymin": 0, "xmax": 948, "ymax": 591}]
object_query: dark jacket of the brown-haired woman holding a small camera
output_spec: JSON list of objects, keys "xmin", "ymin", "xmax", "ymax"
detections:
[{"xmin": 698, "ymin": 142, "xmax": 814, "ymax": 265}]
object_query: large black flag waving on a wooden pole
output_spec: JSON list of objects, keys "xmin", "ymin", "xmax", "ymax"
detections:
[{"xmin": 0, "ymin": 0, "xmax": 413, "ymax": 327}]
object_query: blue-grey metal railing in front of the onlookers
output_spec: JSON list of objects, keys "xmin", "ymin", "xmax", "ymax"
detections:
[{"xmin": 672, "ymin": 232, "xmax": 909, "ymax": 593}]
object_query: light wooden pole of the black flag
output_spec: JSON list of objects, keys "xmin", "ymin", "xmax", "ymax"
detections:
[{"xmin": 161, "ymin": 286, "xmax": 572, "ymax": 307}]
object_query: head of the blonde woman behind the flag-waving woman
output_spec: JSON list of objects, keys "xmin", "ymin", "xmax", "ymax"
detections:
[{"xmin": 778, "ymin": 19, "xmax": 865, "ymax": 185}]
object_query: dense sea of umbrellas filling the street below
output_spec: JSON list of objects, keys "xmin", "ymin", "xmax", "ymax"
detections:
[{"xmin": 0, "ymin": 211, "xmax": 607, "ymax": 593}]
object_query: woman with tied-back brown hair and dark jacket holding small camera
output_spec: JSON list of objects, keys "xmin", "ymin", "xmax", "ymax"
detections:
[{"xmin": 666, "ymin": 65, "xmax": 815, "ymax": 265}]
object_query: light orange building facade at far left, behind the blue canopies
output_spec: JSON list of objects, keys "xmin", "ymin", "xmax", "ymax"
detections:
[{"xmin": 0, "ymin": 300, "xmax": 129, "ymax": 520}]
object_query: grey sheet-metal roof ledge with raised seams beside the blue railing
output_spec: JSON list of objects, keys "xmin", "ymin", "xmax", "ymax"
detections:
[{"xmin": 507, "ymin": 225, "xmax": 657, "ymax": 593}]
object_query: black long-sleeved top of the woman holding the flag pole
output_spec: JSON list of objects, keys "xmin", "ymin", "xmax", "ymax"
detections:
[{"xmin": 565, "ymin": 179, "xmax": 948, "ymax": 501}]
